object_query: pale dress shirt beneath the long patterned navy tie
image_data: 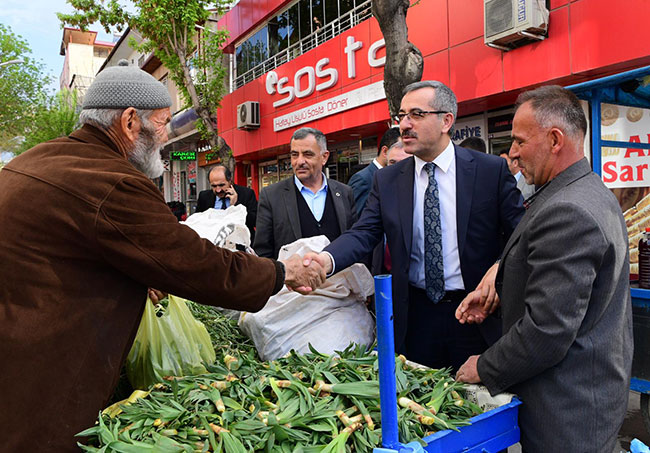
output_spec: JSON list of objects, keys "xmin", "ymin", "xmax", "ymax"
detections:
[{"xmin": 409, "ymin": 141, "xmax": 465, "ymax": 291}]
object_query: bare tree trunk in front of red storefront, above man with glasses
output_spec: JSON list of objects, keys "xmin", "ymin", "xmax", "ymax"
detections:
[{"xmin": 372, "ymin": 0, "xmax": 424, "ymax": 116}]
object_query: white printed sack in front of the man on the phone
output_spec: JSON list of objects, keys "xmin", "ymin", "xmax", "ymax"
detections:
[{"xmin": 181, "ymin": 204, "xmax": 251, "ymax": 250}]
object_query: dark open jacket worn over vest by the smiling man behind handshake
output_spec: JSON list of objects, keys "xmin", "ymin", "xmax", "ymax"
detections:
[{"xmin": 253, "ymin": 177, "xmax": 357, "ymax": 259}]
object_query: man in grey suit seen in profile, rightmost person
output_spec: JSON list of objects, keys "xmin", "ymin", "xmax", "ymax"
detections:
[{"xmin": 457, "ymin": 86, "xmax": 633, "ymax": 453}]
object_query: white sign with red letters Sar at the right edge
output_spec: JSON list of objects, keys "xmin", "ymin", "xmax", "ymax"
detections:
[{"xmin": 601, "ymin": 104, "xmax": 650, "ymax": 188}]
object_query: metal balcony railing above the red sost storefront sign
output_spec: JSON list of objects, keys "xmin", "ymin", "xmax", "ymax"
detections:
[{"xmin": 234, "ymin": 0, "xmax": 372, "ymax": 90}]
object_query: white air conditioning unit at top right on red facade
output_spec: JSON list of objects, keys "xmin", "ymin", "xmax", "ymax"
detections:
[{"xmin": 484, "ymin": 0, "xmax": 549, "ymax": 51}]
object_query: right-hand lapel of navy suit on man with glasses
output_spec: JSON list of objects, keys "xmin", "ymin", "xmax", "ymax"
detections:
[{"xmin": 454, "ymin": 145, "xmax": 476, "ymax": 260}]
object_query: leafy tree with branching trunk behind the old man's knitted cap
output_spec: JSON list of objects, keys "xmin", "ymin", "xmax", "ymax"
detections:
[{"xmin": 57, "ymin": 0, "xmax": 234, "ymax": 168}]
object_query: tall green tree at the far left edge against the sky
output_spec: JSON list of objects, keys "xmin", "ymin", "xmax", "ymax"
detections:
[{"xmin": 0, "ymin": 24, "xmax": 49, "ymax": 152}]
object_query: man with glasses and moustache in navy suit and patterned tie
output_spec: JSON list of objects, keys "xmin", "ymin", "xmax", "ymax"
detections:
[{"xmin": 298, "ymin": 81, "xmax": 523, "ymax": 368}]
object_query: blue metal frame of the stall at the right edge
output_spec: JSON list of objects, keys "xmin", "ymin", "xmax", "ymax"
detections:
[{"xmin": 567, "ymin": 66, "xmax": 650, "ymax": 433}]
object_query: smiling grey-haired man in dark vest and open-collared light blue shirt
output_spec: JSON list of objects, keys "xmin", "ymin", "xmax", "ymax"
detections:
[{"xmin": 253, "ymin": 127, "xmax": 357, "ymax": 258}]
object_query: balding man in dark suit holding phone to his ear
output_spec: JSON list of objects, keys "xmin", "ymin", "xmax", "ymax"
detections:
[{"xmin": 196, "ymin": 165, "xmax": 257, "ymax": 240}]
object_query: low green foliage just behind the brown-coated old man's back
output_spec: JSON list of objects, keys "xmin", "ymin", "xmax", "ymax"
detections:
[{"xmin": 15, "ymin": 90, "xmax": 79, "ymax": 154}]
